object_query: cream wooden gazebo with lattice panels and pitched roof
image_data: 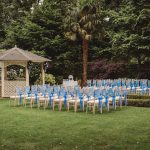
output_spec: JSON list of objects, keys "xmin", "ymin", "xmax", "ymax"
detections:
[{"xmin": 0, "ymin": 46, "xmax": 51, "ymax": 97}]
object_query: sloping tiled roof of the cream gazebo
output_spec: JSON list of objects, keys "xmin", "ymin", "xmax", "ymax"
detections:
[{"xmin": 0, "ymin": 46, "xmax": 51, "ymax": 62}]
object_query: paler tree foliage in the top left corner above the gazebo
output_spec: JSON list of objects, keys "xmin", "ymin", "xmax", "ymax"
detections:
[{"xmin": 0, "ymin": 0, "xmax": 37, "ymax": 47}]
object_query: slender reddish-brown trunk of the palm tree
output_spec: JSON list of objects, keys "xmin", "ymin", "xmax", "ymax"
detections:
[{"xmin": 82, "ymin": 39, "xmax": 88, "ymax": 86}]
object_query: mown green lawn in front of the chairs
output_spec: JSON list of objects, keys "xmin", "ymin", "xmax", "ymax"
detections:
[{"xmin": 0, "ymin": 100, "xmax": 150, "ymax": 150}]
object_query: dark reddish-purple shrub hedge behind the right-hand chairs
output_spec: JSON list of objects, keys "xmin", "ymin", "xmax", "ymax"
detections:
[{"xmin": 88, "ymin": 59, "xmax": 150, "ymax": 79}]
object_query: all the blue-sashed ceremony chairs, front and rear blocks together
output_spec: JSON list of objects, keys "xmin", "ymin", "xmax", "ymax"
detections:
[{"xmin": 10, "ymin": 79, "xmax": 150, "ymax": 114}]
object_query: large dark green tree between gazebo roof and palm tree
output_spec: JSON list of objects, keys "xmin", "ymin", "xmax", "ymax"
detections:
[{"xmin": 0, "ymin": 0, "xmax": 81, "ymax": 81}]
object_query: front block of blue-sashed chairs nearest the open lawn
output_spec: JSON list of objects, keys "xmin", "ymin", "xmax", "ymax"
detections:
[{"xmin": 10, "ymin": 85, "xmax": 127, "ymax": 113}]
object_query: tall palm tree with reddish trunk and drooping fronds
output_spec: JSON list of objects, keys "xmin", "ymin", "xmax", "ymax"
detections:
[{"xmin": 64, "ymin": 2, "xmax": 104, "ymax": 86}]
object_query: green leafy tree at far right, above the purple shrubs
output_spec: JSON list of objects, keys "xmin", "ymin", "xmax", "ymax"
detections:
[{"xmin": 107, "ymin": 0, "xmax": 150, "ymax": 64}]
